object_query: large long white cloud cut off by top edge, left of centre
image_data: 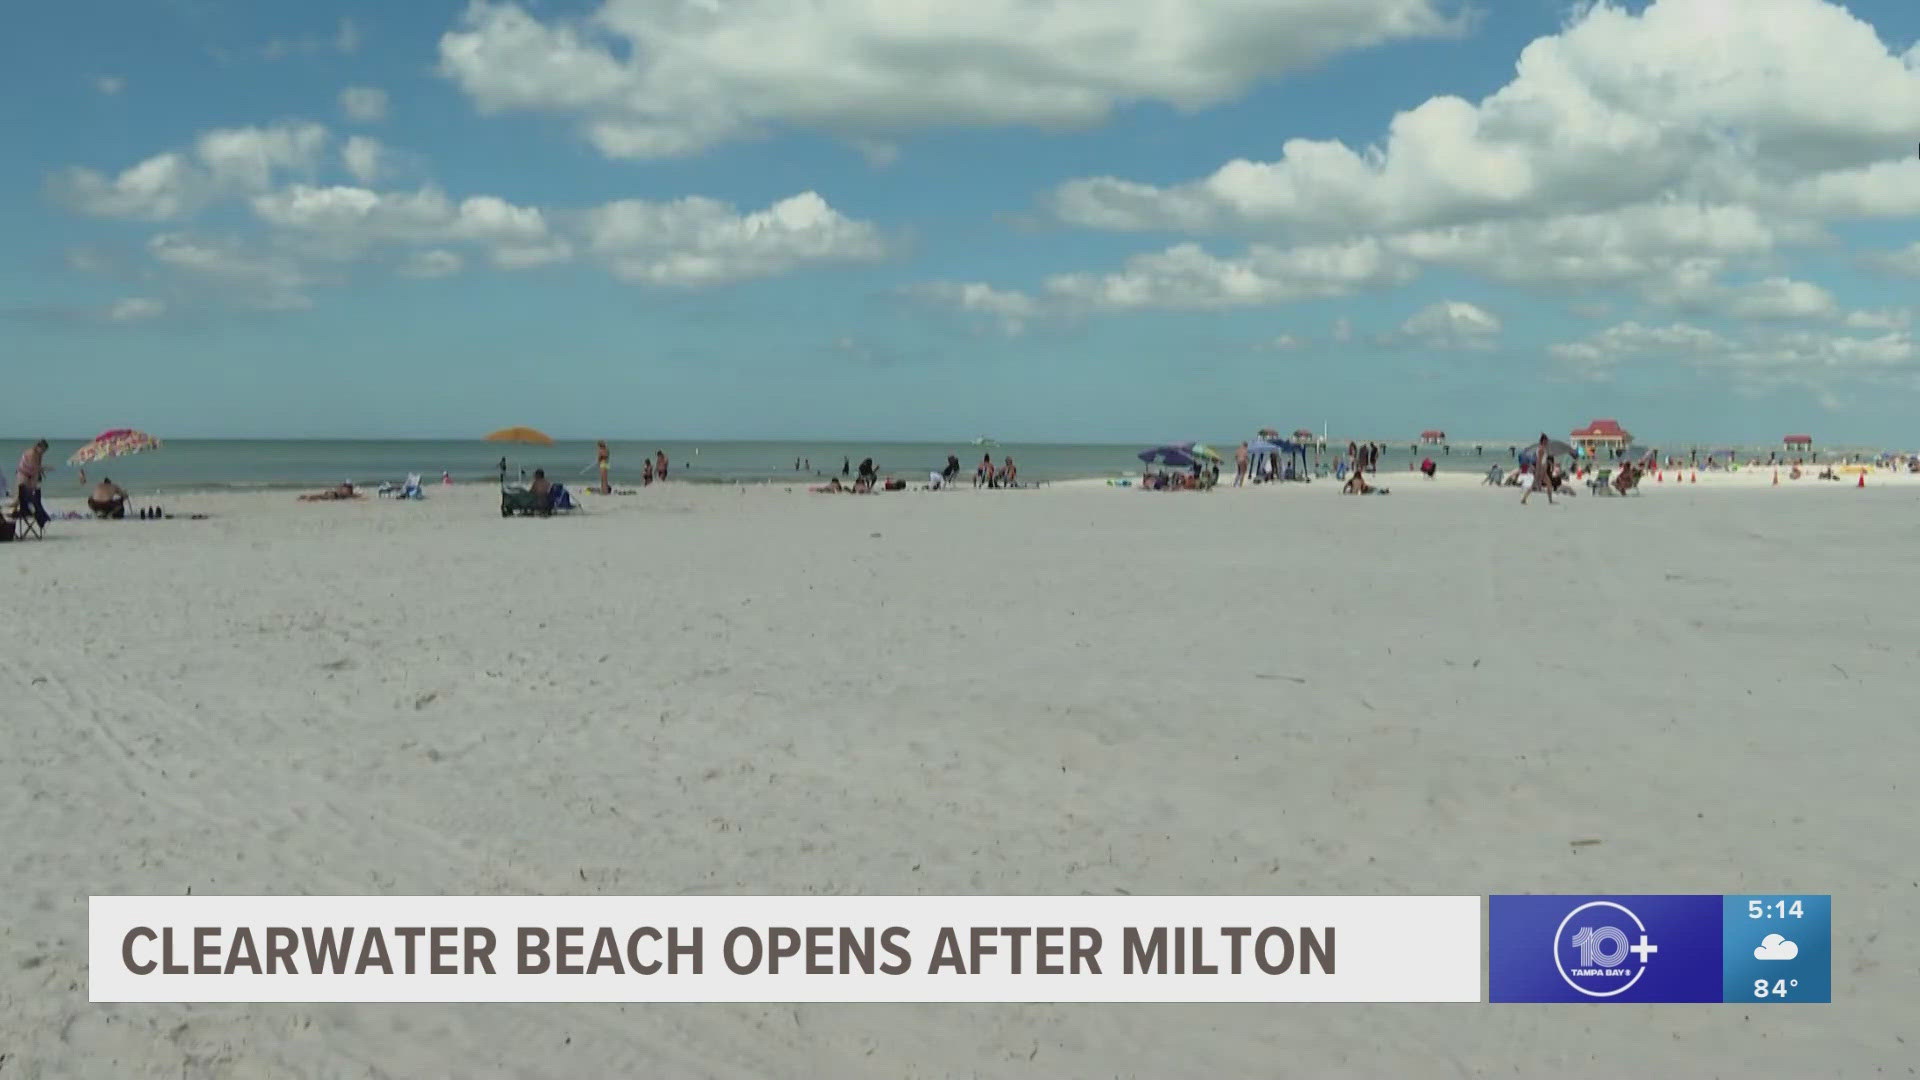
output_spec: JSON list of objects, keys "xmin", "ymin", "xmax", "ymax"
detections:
[{"xmin": 440, "ymin": 0, "xmax": 1459, "ymax": 158}]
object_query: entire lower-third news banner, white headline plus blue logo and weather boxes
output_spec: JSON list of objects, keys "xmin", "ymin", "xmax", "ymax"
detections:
[{"xmin": 88, "ymin": 894, "xmax": 1832, "ymax": 1005}]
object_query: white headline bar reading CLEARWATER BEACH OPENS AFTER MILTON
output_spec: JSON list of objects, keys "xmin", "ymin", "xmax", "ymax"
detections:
[{"xmin": 88, "ymin": 896, "xmax": 1482, "ymax": 1003}]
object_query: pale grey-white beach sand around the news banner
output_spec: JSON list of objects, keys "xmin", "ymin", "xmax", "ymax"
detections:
[{"xmin": 0, "ymin": 475, "xmax": 1920, "ymax": 1078}]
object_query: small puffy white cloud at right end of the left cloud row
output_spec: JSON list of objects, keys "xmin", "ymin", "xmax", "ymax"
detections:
[{"xmin": 582, "ymin": 192, "xmax": 887, "ymax": 286}]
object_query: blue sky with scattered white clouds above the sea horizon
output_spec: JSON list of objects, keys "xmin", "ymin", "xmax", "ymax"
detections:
[{"xmin": 0, "ymin": 0, "xmax": 1920, "ymax": 446}]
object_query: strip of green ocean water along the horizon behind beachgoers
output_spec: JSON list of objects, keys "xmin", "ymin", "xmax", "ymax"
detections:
[{"xmin": 0, "ymin": 438, "xmax": 1881, "ymax": 494}]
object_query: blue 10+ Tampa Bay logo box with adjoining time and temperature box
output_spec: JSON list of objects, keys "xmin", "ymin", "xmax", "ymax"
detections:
[{"xmin": 1486, "ymin": 894, "xmax": 1834, "ymax": 1005}]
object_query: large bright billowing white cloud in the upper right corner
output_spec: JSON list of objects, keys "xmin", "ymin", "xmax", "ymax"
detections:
[{"xmin": 1056, "ymin": 0, "xmax": 1920, "ymax": 231}]
